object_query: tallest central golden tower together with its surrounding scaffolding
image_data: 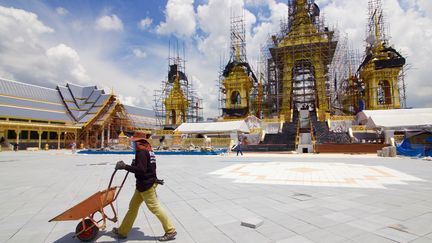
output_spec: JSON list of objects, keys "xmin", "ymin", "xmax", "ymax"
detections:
[{"xmin": 263, "ymin": 0, "xmax": 340, "ymax": 119}]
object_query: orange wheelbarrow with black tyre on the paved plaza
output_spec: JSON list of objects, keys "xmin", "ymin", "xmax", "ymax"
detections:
[{"xmin": 48, "ymin": 170, "xmax": 129, "ymax": 241}]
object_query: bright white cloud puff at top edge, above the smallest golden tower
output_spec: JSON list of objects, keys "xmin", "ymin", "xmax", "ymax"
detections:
[{"xmin": 156, "ymin": 0, "xmax": 196, "ymax": 38}]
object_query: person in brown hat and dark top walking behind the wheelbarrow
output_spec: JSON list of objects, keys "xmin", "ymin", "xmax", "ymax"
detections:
[{"xmin": 112, "ymin": 132, "xmax": 177, "ymax": 241}]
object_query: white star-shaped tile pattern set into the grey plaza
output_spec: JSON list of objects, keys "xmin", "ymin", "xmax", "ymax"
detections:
[{"xmin": 211, "ymin": 162, "xmax": 423, "ymax": 188}]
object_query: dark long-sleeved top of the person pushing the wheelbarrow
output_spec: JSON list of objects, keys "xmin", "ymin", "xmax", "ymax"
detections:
[{"xmin": 126, "ymin": 150, "xmax": 157, "ymax": 192}]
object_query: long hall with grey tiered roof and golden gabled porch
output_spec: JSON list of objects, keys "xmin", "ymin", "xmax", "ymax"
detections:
[{"xmin": 0, "ymin": 78, "xmax": 156, "ymax": 150}]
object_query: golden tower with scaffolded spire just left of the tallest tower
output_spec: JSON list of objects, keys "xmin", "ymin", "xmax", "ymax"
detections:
[{"xmin": 221, "ymin": 14, "xmax": 257, "ymax": 119}]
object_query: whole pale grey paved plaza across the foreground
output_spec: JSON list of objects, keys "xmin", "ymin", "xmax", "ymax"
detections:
[{"xmin": 0, "ymin": 151, "xmax": 432, "ymax": 243}]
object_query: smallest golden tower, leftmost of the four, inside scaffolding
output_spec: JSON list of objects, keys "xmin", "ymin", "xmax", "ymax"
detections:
[{"xmin": 164, "ymin": 71, "xmax": 189, "ymax": 126}]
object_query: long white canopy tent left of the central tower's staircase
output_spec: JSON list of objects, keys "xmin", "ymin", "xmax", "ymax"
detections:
[{"xmin": 175, "ymin": 120, "xmax": 249, "ymax": 134}]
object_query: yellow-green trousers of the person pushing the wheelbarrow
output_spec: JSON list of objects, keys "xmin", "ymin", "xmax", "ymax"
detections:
[{"xmin": 118, "ymin": 183, "xmax": 175, "ymax": 236}]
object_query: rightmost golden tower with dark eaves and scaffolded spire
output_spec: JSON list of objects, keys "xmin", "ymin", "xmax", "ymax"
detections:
[{"xmin": 359, "ymin": 0, "xmax": 405, "ymax": 110}]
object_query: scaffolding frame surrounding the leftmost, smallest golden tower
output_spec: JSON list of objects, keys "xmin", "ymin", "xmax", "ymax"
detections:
[{"xmin": 153, "ymin": 43, "xmax": 204, "ymax": 129}]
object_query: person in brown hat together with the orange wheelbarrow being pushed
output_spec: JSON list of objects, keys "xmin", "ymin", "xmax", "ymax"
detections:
[{"xmin": 49, "ymin": 132, "xmax": 177, "ymax": 241}]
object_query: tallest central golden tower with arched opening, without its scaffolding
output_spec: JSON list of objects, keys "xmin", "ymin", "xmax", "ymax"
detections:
[{"xmin": 270, "ymin": 0, "xmax": 337, "ymax": 120}]
